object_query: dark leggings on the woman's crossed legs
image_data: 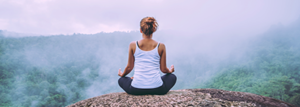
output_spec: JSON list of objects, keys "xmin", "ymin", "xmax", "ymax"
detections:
[{"xmin": 118, "ymin": 74, "xmax": 177, "ymax": 95}]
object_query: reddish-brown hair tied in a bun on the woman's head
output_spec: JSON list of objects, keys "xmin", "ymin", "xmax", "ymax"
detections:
[{"xmin": 140, "ymin": 17, "xmax": 158, "ymax": 36}]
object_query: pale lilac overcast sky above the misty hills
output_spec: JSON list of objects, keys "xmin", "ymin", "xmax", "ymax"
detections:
[{"xmin": 0, "ymin": 0, "xmax": 300, "ymax": 35}]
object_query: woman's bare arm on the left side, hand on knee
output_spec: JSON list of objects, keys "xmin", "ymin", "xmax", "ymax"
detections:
[{"xmin": 118, "ymin": 42, "xmax": 135, "ymax": 77}]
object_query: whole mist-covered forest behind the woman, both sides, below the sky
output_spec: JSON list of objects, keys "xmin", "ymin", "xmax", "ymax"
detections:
[{"xmin": 0, "ymin": 21, "xmax": 300, "ymax": 107}]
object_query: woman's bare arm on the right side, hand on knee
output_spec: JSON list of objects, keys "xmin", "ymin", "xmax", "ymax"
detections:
[{"xmin": 158, "ymin": 43, "xmax": 174, "ymax": 73}]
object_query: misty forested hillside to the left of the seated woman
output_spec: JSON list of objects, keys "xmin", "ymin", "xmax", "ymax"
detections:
[{"xmin": 0, "ymin": 32, "xmax": 136, "ymax": 107}]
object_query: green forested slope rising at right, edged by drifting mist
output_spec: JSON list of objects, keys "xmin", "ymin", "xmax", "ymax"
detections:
[{"xmin": 202, "ymin": 23, "xmax": 300, "ymax": 106}]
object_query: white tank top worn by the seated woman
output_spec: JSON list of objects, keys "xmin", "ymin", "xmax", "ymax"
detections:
[{"xmin": 131, "ymin": 42, "xmax": 163, "ymax": 89}]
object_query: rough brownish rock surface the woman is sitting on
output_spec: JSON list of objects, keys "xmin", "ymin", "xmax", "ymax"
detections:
[{"xmin": 68, "ymin": 89, "xmax": 296, "ymax": 107}]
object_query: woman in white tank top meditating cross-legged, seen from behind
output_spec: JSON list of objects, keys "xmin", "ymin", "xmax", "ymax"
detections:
[{"xmin": 118, "ymin": 17, "xmax": 176, "ymax": 95}]
